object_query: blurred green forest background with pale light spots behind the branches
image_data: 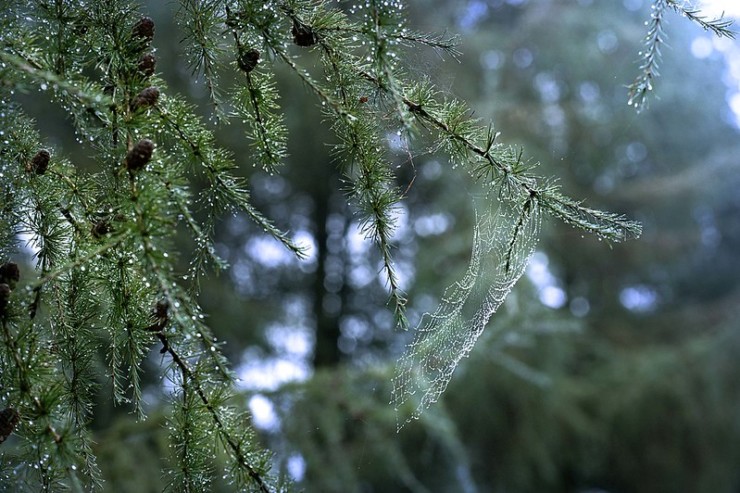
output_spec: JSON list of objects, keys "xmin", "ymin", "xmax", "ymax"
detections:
[{"xmin": 15, "ymin": 0, "xmax": 740, "ymax": 492}]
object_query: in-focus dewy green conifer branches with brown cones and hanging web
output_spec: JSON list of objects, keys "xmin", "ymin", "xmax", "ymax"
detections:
[{"xmin": 0, "ymin": 0, "xmax": 730, "ymax": 492}]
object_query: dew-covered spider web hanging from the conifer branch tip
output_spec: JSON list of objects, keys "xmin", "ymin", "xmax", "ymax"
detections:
[{"xmin": 391, "ymin": 197, "xmax": 541, "ymax": 430}]
